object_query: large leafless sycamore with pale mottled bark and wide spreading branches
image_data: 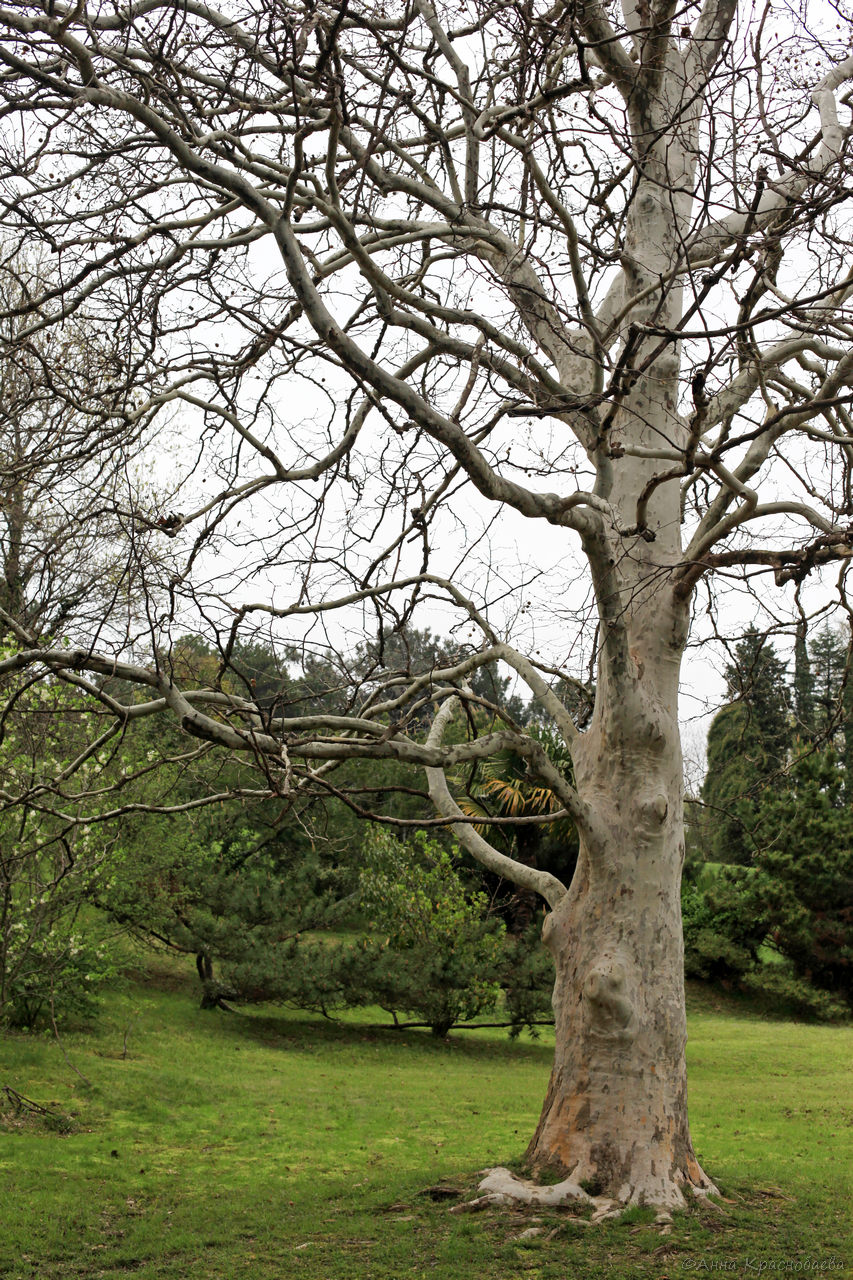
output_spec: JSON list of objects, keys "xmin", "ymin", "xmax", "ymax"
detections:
[{"xmin": 0, "ymin": 0, "xmax": 853, "ymax": 1206}]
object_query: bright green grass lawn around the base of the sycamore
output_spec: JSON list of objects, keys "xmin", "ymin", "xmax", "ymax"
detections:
[{"xmin": 0, "ymin": 969, "xmax": 853, "ymax": 1280}]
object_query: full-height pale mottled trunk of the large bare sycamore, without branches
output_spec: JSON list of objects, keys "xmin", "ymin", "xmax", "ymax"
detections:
[{"xmin": 512, "ymin": 54, "xmax": 713, "ymax": 1207}]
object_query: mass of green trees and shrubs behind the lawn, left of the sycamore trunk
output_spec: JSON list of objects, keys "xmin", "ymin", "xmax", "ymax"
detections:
[{"xmin": 0, "ymin": 631, "xmax": 563, "ymax": 1036}]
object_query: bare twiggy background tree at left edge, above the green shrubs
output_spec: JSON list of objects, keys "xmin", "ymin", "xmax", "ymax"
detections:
[{"xmin": 0, "ymin": 247, "xmax": 168, "ymax": 640}]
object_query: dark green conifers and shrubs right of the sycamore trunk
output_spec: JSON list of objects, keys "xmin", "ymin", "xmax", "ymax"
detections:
[{"xmin": 683, "ymin": 627, "xmax": 853, "ymax": 1018}]
